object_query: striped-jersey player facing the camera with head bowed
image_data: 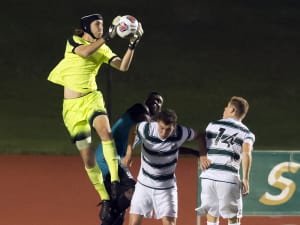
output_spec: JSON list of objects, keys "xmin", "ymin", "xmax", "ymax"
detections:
[{"xmin": 123, "ymin": 109, "xmax": 201, "ymax": 225}]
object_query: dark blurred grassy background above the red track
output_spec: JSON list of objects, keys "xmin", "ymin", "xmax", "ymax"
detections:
[{"xmin": 0, "ymin": 0, "xmax": 300, "ymax": 155}]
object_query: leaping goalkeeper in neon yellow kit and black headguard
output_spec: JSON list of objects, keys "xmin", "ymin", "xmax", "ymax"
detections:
[{"xmin": 48, "ymin": 14, "xmax": 143, "ymax": 219}]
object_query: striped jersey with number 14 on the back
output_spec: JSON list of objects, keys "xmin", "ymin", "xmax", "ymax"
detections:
[{"xmin": 200, "ymin": 118, "xmax": 255, "ymax": 182}]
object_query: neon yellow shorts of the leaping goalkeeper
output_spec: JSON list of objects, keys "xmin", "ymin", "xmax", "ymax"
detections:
[{"xmin": 63, "ymin": 91, "xmax": 107, "ymax": 143}]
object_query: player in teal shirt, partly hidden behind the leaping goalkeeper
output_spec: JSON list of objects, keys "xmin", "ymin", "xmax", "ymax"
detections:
[{"xmin": 96, "ymin": 92, "xmax": 163, "ymax": 225}]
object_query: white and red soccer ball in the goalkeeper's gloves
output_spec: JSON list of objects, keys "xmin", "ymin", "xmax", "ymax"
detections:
[{"xmin": 117, "ymin": 15, "xmax": 139, "ymax": 38}]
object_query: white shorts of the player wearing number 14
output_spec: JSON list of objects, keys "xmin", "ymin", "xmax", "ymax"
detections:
[{"xmin": 196, "ymin": 179, "xmax": 243, "ymax": 219}]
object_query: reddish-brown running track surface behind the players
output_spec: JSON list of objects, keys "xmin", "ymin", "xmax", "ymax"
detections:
[{"xmin": 0, "ymin": 155, "xmax": 300, "ymax": 225}]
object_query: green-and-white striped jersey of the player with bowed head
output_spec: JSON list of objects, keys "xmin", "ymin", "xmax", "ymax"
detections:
[{"xmin": 137, "ymin": 122, "xmax": 195, "ymax": 189}]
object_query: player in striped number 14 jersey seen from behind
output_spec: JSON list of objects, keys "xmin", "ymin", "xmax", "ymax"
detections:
[{"xmin": 196, "ymin": 96, "xmax": 255, "ymax": 225}]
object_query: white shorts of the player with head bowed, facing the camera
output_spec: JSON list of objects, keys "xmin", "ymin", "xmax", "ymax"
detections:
[{"xmin": 130, "ymin": 182, "xmax": 178, "ymax": 219}]
